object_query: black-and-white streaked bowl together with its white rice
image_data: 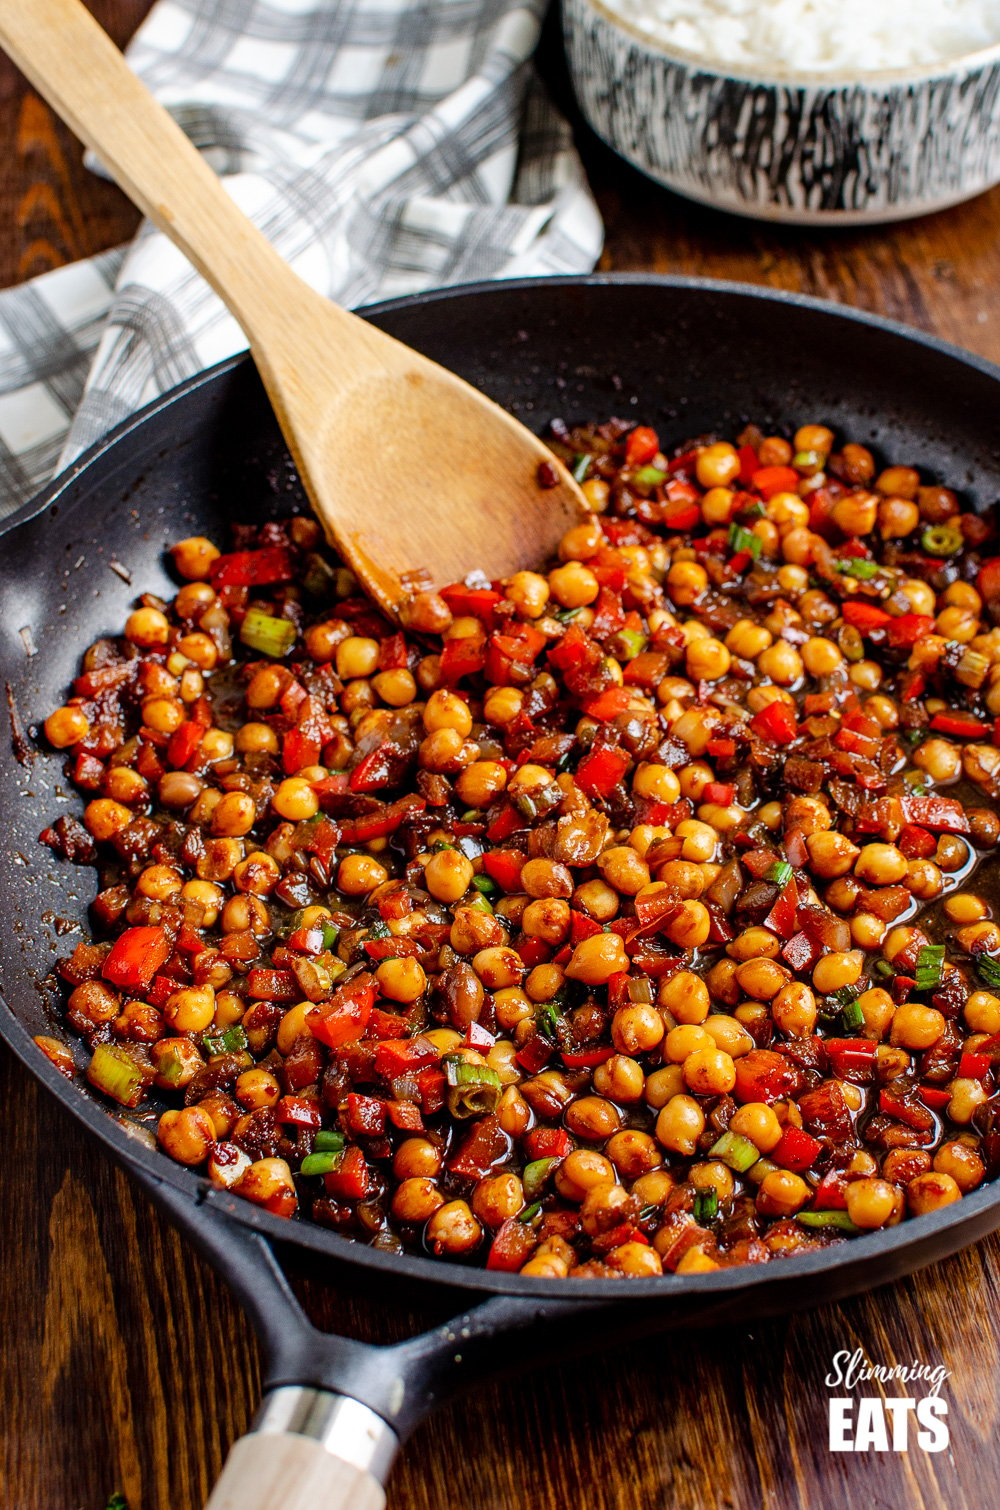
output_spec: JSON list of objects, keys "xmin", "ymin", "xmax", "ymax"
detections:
[{"xmin": 562, "ymin": 0, "xmax": 1000, "ymax": 225}]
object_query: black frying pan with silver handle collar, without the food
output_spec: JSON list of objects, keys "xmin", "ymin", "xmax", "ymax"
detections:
[{"xmin": 0, "ymin": 276, "xmax": 1000, "ymax": 1504}]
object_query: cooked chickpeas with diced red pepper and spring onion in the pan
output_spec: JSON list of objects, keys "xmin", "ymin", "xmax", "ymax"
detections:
[{"xmin": 38, "ymin": 421, "xmax": 1000, "ymax": 1277}]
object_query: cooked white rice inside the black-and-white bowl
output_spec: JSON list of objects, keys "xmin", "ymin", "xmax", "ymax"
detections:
[{"xmin": 604, "ymin": 0, "xmax": 1000, "ymax": 77}]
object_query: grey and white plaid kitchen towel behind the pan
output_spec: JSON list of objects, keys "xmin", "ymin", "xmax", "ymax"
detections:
[{"xmin": 0, "ymin": 0, "xmax": 601, "ymax": 516}]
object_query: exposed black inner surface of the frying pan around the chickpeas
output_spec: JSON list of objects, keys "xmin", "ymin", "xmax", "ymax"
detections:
[{"xmin": 0, "ymin": 278, "xmax": 1000, "ymax": 1293}]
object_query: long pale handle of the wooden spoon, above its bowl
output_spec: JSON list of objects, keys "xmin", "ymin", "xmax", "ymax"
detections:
[{"xmin": 0, "ymin": 0, "xmax": 305, "ymax": 341}]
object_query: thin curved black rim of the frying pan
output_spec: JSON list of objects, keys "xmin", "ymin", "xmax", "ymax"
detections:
[{"xmin": 0, "ymin": 272, "xmax": 1000, "ymax": 1302}]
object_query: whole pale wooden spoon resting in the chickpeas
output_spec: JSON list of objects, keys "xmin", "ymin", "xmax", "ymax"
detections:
[{"xmin": 0, "ymin": 0, "xmax": 586, "ymax": 615}]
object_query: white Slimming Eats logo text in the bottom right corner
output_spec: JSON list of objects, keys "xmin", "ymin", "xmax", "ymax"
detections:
[{"xmin": 825, "ymin": 1347, "xmax": 952, "ymax": 1453}]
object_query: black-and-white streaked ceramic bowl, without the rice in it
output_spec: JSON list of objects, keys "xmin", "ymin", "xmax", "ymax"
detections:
[{"xmin": 562, "ymin": 0, "xmax": 1000, "ymax": 225}]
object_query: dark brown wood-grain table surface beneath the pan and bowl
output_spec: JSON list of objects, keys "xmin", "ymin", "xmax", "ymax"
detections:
[{"xmin": 0, "ymin": 0, "xmax": 1000, "ymax": 1510}]
